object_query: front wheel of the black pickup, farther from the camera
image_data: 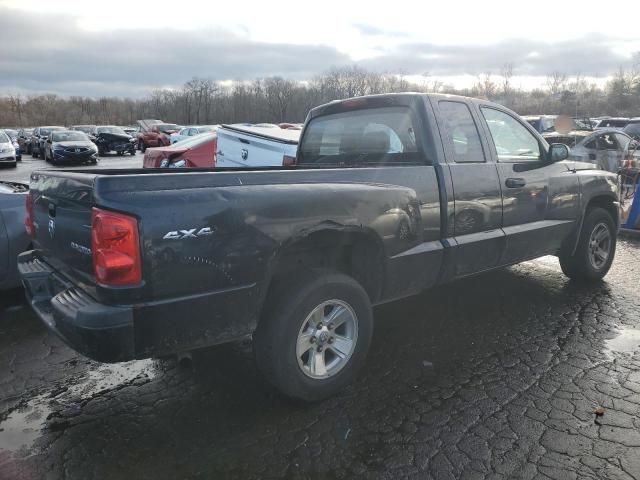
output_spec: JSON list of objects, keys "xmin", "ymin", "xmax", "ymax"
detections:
[{"xmin": 559, "ymin": 207, "xmax": 617, "ymax": 283}]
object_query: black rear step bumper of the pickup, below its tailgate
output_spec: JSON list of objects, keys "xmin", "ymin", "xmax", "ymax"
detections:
[{"xmin": 18, "ymin": 251, "xmax": 135, "ymax": 362}]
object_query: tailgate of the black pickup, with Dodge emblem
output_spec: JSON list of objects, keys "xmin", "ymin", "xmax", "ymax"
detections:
[{"xmin": 30, "ymin": 171, "xmax": 94, "ymax": 284}]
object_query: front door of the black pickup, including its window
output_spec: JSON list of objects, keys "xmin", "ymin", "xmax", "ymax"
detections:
[{"xmin": 480, "ymin": 106, "xmax": 580, "ymax": 265}]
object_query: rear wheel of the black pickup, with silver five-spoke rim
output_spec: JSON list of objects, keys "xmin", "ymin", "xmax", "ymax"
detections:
[{"xmin": 254, "ymin": 270, "xmax": 373, "ymax": 402}]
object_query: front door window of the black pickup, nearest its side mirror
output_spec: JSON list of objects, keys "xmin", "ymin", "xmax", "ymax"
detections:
[{"xmin": 481, "ymin": 107, "xmax": 542, "ymax": 162}]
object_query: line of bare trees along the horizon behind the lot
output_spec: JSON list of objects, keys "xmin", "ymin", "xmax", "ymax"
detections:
[{"xmin": 0, "ymin": 62, "xmax": 640, "ymax": 127}]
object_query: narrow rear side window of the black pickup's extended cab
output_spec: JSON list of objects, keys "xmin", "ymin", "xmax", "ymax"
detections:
[{"xmin": 438, "ymin": 100, "xmax": 486, "ymax": 163}]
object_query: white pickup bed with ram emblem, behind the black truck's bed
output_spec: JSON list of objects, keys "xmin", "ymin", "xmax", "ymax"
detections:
[{"xmin": 216, "ymin": 125, "xmax": 301, "ymax": 168}]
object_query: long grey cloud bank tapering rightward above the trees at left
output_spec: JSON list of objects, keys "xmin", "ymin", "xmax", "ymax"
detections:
[{"xmin": 0, "ymin": 7, "xmax": 352, "ymax": 97}]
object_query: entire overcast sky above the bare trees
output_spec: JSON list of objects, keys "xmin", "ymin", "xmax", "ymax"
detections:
[{"xmin": 0, "ymin": 0, "xmax": 640, "ymax": 97}]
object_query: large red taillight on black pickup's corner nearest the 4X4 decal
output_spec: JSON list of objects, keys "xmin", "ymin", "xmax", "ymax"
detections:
[{"xmin": 91, "ymin": 208, "xmax": 142, "ymax": 286}]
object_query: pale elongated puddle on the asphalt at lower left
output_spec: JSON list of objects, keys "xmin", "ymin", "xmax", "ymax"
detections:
[{"xmin": 0, "ymin": 359, "xmax": 158, "ymax": 455}]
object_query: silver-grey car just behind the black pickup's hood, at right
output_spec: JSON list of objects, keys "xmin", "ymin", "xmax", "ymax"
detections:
[{"xmin": 543, "ymin": 128, "xmax": 640, "ymax": 173}]
